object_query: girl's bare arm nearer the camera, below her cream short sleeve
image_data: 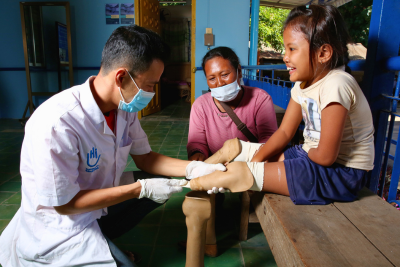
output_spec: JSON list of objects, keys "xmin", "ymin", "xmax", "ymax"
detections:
[{"xmin": 308, "ymin": 103, "xmax": 348, "ymax": 167}]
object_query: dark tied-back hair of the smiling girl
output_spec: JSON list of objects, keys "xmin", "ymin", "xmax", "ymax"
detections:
[{"xmin": 283, "ymin": 5, "xmax": 350, "ymax": 72}]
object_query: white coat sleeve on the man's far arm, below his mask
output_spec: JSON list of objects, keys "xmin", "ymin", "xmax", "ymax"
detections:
[{"xmin": 128, "ymin": 112, "xmax": 151, "ymax": 155}]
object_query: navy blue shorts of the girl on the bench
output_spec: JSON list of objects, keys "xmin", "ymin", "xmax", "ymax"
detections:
[{"xmin": 283, "ymin": 145, "xmax": 367, "ymax": 205}]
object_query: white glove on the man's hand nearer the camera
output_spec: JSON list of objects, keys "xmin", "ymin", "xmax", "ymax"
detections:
[{"xmin": 138, "ymin": 178, "xmax": 187, "ymax": 204}]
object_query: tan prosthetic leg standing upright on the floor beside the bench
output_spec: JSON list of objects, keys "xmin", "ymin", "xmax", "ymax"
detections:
[{"xmin": 182, "ymin": 191, "xmax": 215, "ymax": 267}]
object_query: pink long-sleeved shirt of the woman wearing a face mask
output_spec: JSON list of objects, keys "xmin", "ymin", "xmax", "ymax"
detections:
[{"xmin": 187, "ymin": 86, "xmax": 278, "ymax": 158}]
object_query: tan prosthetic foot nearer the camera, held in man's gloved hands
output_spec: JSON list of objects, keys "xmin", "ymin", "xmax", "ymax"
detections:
[{"xmin": 185, "ymin": 161, "xmax": 255, "ymax": 193}]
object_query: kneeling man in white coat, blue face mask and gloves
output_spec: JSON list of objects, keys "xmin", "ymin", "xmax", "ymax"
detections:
[{"xmin": 0, "ymin": 26, "xmax": 225, "ymax": 267}]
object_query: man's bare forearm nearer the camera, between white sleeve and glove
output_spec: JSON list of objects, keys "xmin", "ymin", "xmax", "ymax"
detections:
[{"xmin": 54, "ymin": 182, "xmax": 142, "ymax": 215}]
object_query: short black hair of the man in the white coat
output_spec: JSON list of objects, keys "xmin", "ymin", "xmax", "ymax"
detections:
[{"xmin": 101, "ymin": 25, "xmax": 170, "ymax": 76}]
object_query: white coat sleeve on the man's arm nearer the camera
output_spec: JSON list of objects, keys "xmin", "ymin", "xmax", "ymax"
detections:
[{"xmin": 30, "ymin": 120, "xmax": 80, "ymax": 206}]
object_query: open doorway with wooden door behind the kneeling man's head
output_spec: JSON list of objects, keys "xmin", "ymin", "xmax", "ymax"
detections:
[{"xmin": 135, "ymin": 0, "xmax": 195, "ymax": 118}]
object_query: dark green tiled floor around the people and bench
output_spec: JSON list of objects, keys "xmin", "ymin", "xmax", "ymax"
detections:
[{"xmin": 0, "ymin": 101, "xmax": 276, "ymax": 267}]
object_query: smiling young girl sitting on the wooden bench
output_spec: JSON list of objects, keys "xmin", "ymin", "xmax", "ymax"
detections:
[{"xmin": 191, "ymin": 5, "xmax": 374, "ymax": 204}]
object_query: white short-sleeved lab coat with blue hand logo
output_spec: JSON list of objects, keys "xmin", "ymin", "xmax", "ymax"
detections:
[{"xmin": 0, "ymin": 77, "xmax": 151, "ymax": 267}]
